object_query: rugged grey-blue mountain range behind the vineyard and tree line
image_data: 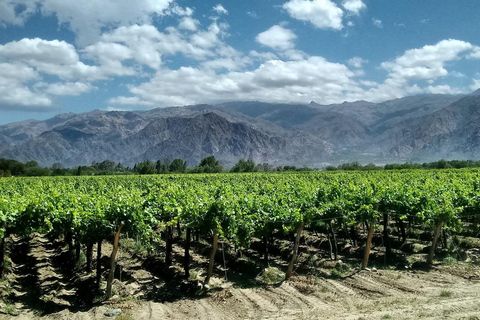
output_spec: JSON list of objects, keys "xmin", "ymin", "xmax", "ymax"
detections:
[{"xmin": 0, "ymin": 91, "xmax": 480, "ymax": 167}]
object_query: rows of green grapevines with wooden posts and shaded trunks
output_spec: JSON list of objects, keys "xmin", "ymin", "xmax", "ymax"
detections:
[{"xmin": 0, "ymin": 169, "xmax": 480, "ymax": 314}]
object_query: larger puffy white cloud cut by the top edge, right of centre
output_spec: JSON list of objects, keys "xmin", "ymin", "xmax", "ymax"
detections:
[{"xmin": 283, "ymin": 0, "xmax": 343, "ymax": 30}]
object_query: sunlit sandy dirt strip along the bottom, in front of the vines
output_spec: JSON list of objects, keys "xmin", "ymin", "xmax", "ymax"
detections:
[{"xmin": 0, "ymin": 265, "xmax": 480, "ymax": 320}]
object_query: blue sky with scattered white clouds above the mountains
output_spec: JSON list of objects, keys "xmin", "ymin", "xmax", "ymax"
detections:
[{"xmin": 0, "ymin": 0, "xmax": 480, "ymax": 124}]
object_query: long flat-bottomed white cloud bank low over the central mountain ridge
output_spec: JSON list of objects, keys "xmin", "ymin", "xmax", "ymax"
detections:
[{"xmin": 112, "ymin": 57, "xmax": 355, "ymax": 106}]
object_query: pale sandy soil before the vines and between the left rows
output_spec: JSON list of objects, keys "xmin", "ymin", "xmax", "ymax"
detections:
[{"xmin": 0, "ymin": 234, "xmax": 480, "ymax": 320}]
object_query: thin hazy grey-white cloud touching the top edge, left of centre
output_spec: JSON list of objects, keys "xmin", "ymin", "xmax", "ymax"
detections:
[{"xmin": 41, "ymin": 0, "xmax": 172, "ymax": 47}]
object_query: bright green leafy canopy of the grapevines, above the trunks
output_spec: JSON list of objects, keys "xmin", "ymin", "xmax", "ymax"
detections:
[{"xmin": 0, "ymin": 169, "xmax": 480, "ymax": 282}]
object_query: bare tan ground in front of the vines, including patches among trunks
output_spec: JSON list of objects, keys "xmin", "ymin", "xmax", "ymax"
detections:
[{"xmin": 0, "ymin": 232, "xmax": 480, "ymax": 320}]
